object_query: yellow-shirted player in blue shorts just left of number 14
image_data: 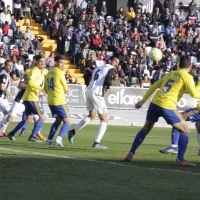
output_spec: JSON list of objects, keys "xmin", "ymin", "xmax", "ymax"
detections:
[{"xmin": 24, "ymin": 55, "xmax": 46, "ymax": 142}]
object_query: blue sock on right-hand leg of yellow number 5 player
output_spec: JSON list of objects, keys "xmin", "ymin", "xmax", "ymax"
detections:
[{"xmin": 177, "ymin": 133, "xmax": 189, "ymax": 161}]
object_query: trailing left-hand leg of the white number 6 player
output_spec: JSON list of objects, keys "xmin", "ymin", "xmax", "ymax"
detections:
[{"xmin": 68, "ymin": 92, "xmax": 96, "ymax": 143}]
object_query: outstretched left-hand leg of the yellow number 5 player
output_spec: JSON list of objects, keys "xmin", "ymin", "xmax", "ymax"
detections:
[{"xmin": 125, "ymin": 103, "xmax": 162, "ymax": 161}]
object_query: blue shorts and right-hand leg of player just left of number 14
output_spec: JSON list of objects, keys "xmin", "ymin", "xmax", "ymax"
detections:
[{"xmin": 24, "ymin": 101, "xmax": 46, "ymax": 142}]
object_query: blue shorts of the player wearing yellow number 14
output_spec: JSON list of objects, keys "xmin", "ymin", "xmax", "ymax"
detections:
[{"xmin": 49, "ymin": 105, "xmax": 70, "ymax": 119}]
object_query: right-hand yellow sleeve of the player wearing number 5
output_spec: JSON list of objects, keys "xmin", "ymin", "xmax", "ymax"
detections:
[{"xmin": 184, "ymin": 77, "xmax": 200, "ymax": 98}]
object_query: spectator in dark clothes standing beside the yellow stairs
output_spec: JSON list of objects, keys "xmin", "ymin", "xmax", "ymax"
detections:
[{"xmin": 57, "ymin": 22, "xmax": 68, "ymax": 55}]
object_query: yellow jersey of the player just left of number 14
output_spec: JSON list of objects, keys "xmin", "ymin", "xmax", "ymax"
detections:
[{"xmin": 24, "ymin": 67, "xmax": 46, "ymax": 101}]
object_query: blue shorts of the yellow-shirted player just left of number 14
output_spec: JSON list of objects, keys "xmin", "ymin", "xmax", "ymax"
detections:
[{"xmin": 24, "ymin": 101, "xmax": 44, "ymax": 118}]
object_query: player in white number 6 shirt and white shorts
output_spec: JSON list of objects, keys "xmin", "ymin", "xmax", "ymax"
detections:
[{"xmin": 68, "ymin": 57, "xmax": 119, "ymax": 149}]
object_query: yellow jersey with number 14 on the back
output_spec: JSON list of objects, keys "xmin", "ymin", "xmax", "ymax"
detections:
[{"xmin": 44, "ymin": 67, "xmax": 68, "ymax": 106}]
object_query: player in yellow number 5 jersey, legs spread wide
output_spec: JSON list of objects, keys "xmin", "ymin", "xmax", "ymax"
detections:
[{"xmin": 125, "ymin": 55, "xmax": 200, "ymax": 166}]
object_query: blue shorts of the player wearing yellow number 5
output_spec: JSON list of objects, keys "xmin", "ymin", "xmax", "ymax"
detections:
[{"xmin": 146, "ymin": 103, "xmax": 183, "ymax": 124}]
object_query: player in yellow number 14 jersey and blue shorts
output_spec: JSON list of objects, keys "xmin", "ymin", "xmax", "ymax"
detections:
[{"xmin": 44, "ymin": 55, "xmax": 71, "ymax": 146}]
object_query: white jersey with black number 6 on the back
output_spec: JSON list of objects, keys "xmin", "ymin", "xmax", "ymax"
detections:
[{"xmin": 88, "ymin": 64, "xmax": 114, "ymax": 96}]
